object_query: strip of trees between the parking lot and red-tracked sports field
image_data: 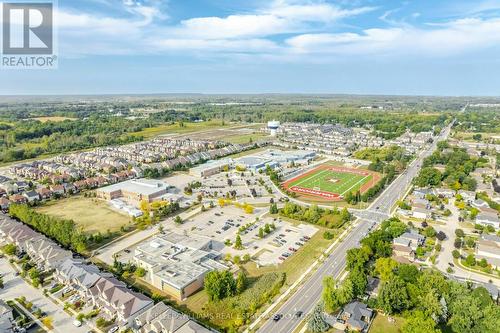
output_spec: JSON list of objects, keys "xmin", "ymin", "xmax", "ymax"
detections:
[{"xmin": 279, "ymin": 202, "xmax": 352, "ymax": 228}]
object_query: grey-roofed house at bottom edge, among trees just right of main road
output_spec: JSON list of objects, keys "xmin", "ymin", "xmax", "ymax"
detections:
[{"xmin": 334, "ymin": 301, "xmax": 373, "ymax": 332}]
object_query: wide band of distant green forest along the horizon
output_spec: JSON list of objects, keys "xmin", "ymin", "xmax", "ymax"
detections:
[{"xmin": 0, "ymin": 97, "xmax": 451, "ymax": 162}]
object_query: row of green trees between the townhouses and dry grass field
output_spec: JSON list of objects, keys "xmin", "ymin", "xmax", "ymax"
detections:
[{"xmin": 9, "ymin": 205, "xmax": 87, "ymax": 253}]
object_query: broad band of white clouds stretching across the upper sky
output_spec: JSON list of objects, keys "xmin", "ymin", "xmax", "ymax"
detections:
[{"xmin": 53, "ymin": 0, "xmax": 500, "ymax": 61}]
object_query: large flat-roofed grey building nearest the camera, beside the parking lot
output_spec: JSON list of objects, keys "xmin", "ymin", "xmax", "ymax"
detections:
[{"xmin": 134, "ymin": 232, "xmax": 227, "ymax": 300}]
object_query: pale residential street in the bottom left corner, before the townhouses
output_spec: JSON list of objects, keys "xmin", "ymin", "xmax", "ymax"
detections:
[{"xmin": 0, "ymin": 258, "xmax": 91, "ymax": 333}]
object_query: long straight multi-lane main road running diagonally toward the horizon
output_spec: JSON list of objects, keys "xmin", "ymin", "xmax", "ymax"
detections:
[{"xmin": 254, "ymin": 124, "xmax": 452, "ymax": 333}]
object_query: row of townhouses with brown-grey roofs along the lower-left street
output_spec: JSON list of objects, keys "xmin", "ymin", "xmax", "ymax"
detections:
[{"xmin": 0, "ymin": 215, "xmax": 211, "ymax": 333}]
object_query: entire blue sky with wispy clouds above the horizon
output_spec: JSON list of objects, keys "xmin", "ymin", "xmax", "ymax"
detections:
[{"xmin": 0, "ymin": 0, "xmax": 500, "ymax": 95}]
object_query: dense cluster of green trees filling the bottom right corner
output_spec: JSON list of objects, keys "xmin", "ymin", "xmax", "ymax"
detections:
[{"xmin": 323, "ymin": 218, "xmax": 500, "ymax": 333}]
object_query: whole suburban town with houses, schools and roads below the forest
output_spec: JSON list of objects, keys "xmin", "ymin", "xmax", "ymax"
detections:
[{"xmin": 0, "ymin": 93, "xmax": 500, "ymax": 333}]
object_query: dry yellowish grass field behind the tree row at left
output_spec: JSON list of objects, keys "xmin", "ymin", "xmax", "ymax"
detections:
[{"xmin": 36, "ymin": 195, "xmax": 131, "ymax": 233}]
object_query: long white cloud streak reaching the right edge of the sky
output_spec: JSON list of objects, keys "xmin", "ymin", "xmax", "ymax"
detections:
[{"xmin": 286, "ymin": 19, "xmax": 500, "ymax": 56}]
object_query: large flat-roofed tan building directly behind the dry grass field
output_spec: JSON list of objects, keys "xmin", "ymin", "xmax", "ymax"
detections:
[{"xmin": 97, "ymin": 178, "xmax": 169, "ymax": 203}]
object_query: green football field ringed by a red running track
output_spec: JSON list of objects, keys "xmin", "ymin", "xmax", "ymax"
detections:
[{"xmin": 283, "ymin": 164, "xmax": 380, "ymax": 201}]
